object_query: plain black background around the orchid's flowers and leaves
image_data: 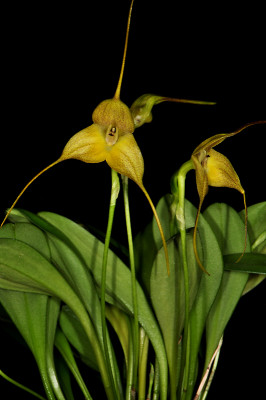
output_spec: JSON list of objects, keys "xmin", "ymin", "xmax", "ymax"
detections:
[{"xmin": 0, "ymin": 0, "xmax": 266, "ymax": 400}]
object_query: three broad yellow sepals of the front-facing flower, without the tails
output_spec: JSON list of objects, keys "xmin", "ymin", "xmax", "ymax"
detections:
[{"xmin": 58, "ymin": 99, "xmax": 144, "ymax": 187}]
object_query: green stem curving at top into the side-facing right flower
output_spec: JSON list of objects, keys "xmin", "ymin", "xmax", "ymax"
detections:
[{"xmin": 171, "ymin": 160, "xmax": 194, "ymax": 399}]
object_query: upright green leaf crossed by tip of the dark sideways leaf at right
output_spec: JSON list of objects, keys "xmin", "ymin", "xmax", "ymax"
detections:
[{"xmin": 204, "ymin": 203, "xmax": 250, "ymax": 371}]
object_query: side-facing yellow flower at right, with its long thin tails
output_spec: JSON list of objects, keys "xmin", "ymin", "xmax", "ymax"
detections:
[{"xmin": 191, "ymin": 121, "xmax": 266, "ymax": 272}]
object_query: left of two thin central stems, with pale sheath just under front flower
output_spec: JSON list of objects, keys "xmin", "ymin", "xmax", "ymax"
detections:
[{"xmin": 101, "ymin": 169, "xmax": 120, "ymax": 398}]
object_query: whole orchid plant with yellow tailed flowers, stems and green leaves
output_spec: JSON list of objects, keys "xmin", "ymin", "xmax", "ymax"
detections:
[{"xmin": 0, "ymin": 0, "xmax": 266, "ymax": 400}]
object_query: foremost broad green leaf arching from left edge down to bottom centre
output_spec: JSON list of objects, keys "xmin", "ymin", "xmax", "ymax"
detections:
[{"xmin": 0, "ymin": 239, "xmax": 111, "ymax": 396}]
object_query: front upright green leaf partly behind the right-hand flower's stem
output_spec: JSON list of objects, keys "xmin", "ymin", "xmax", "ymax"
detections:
[{"xmin": 150, "ymin": 232, "xmax": 201, "ymax": 395}]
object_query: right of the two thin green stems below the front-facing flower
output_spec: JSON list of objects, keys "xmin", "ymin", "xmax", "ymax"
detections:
[{"xmin": 122, "ymin": 176, "xmax": 139, "ymax": 389}]
